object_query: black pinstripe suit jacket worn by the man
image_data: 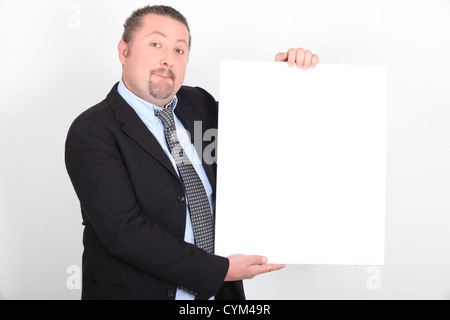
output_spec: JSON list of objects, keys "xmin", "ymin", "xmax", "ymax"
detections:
[{"xmin": 65, "ymin": 84, "xmax": 244, "ymax": 299}]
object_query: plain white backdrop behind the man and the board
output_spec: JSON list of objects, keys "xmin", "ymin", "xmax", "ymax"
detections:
[{"xmin": 0, "ymin": 0, "xmax": 450, "ymax": 299}]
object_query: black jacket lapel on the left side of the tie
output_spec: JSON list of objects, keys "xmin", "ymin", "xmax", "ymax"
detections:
[{"xmin": 107, "ymin": 84, "xmax": 179, "ymax": 180}]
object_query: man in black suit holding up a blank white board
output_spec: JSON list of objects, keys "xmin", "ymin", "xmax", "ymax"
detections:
[{"xmin": 66, "ymin": 6, "xmax": 318, "ymax": 299}]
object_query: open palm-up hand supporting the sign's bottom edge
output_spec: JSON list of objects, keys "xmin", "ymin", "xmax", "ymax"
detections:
[{"xmin": 225, "ymin": 254, "xmax": 285, "ymax": 281}]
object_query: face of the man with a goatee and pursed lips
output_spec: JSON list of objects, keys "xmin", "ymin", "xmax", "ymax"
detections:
[{"xmin": 118, "ymin": 14, "xmax": 189, "ymax": 107}]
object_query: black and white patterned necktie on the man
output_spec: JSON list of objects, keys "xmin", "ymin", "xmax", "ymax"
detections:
[{"xmin": 155, "ymin": 105, "xmax": 214, "ymax": 253}]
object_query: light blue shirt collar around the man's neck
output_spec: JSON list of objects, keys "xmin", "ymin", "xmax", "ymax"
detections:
[{"xmin": 117, "ymin": 79, "xmax": 178, "ymax": 122}]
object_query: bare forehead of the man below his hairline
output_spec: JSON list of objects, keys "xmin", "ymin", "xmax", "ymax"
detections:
[{"xmin": 137, "ymin": 14, "xmax": 189, "ymax": 42}]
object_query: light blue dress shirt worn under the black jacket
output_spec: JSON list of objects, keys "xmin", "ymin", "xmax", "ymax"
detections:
[{"xmin": 117, "ymin": 80, "xmax": 213, "ymax": 300}]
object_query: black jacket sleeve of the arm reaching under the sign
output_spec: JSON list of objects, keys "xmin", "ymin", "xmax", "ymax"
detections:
[{"xmin": 65, "ymin": 110, "xmax": 229, "ymax": 299}]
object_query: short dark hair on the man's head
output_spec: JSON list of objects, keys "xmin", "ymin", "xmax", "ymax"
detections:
[{"xmin": 122, "ymin": 6, "xmax": 192, "ymax": 49}]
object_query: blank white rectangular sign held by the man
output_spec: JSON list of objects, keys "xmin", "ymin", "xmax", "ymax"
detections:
[{"xmin": 216, "ymin": 61, "xmax": 386, "ymax": 265}]
